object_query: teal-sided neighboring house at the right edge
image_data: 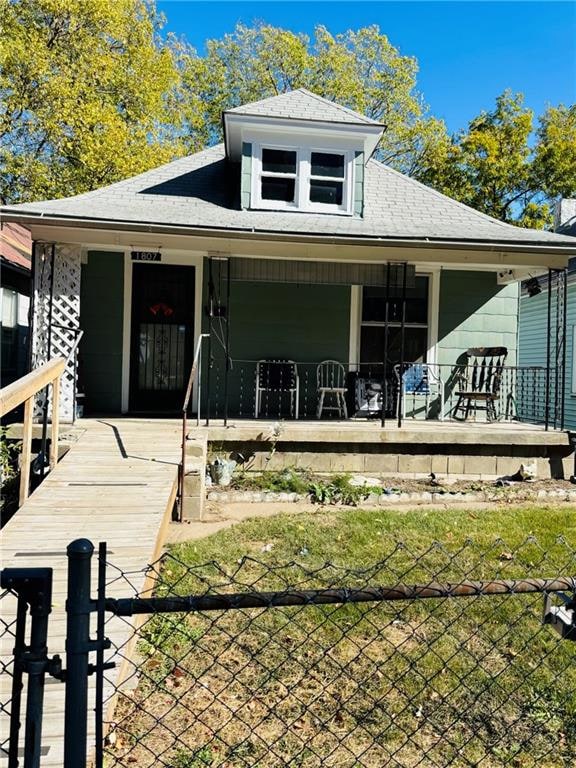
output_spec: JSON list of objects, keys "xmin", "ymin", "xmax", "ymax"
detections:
[{"xmin": 518, "ymin": 199, "xmax": 576, "ymax": 430}]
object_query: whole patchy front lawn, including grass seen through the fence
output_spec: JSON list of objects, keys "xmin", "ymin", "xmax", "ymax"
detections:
[{"xmin": 113, "ymin": 506, "xmax": 576, "ymax": 768}]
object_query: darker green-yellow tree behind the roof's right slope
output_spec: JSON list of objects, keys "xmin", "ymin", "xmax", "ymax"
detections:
[{"xmin": 422, "ymin": 91, "xmax": 576, "ymax": 229}]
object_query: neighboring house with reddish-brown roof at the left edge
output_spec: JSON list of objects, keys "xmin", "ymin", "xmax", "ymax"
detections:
[{"xmin": 0, "ymin": 222, "xmax": 32, "ymax": 387}]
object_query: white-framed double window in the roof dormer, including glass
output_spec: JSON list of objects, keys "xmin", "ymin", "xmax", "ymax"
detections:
[{"xmin": 252, "ymin": 144, "xmax": 354, "ymax": 214}]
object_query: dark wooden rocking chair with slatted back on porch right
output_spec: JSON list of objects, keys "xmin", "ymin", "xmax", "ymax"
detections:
[{"xmin": 452, "ymin": 347, "xmax": 508, "ymax": 421}]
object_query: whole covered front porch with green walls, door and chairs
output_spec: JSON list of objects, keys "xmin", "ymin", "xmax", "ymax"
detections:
[{"xmin": 21, "ymin": 228, "xmax": 566, "ymax": 436}]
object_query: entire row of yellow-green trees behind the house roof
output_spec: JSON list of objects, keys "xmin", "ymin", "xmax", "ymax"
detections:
[{"xmin": 0, "ymin": 6, "xmax": 576, "ymax": 227}]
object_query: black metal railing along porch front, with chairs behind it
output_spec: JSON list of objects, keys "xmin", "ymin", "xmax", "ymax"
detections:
[{"xmin": 199, "ymin": 354, "xmax": 561, "ymax": 429}]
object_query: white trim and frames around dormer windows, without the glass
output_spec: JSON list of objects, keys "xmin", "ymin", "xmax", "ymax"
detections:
[{"xmin": 247, "ymin": 136, "xmax": 355, "ymax": 216}]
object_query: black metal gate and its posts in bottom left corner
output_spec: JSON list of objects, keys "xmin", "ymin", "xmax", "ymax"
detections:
[{"xmin": 0, "ymin": 539, "xmax": 114, "ymax": 768}]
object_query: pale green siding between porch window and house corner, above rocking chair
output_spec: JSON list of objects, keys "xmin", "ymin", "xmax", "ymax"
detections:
[{"xmin": 438, "ymin": 270, "xmax": 518, "ymax": 365}]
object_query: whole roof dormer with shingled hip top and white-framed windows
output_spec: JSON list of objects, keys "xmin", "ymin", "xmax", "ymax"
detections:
[{"xmin": 224, "ymin": 89, "xmax": 383, "ymax": 216}]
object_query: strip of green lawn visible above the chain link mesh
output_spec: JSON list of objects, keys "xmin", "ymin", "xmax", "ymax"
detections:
[{"xmin": 177, "ymin": 505, "xmax": 576, "ymax": 576}]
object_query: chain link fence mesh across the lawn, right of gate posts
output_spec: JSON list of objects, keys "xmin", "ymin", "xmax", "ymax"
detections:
[{"xmin": 104, "ymin": 538, "xmax": 576, "ymax": 768}]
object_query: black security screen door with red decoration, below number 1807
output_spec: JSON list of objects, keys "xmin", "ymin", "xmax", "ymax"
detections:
[{"xmin": 130, "ymin": 264, "xmax": 194, "ymax": 412}]
